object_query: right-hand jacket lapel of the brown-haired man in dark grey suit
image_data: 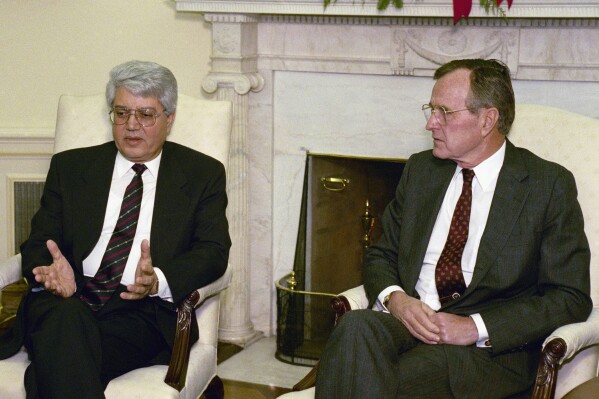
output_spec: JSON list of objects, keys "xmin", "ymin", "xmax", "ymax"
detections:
[{"xmin": 465, "ymin": 141, "xmax": 530, "ymax": 294}]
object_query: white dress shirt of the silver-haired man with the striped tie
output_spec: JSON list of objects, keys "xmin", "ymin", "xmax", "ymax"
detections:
[{"xmin": 83, "ymin": 152, "xmax": 173, "ymax": 302}]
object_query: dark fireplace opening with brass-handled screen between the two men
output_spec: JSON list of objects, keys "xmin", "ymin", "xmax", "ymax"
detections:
[{"xmin": 276, "ymin": 153, "xmax": 406, "ymax": 366}]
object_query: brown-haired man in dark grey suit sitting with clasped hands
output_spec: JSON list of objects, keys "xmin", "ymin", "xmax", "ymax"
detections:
[{"xmin": 316, "ymin": 60, "xmax": 592, "ymax": 399}]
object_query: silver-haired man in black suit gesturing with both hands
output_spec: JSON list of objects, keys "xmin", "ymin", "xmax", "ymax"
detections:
[{"xmin": 0, "ymin": 61, "xmax": 231, "ymax": 398}]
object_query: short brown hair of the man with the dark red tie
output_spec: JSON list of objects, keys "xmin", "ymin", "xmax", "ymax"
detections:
[{"xmin": 434, "ymin": 59, "xmax": 516, "ymax": 135}]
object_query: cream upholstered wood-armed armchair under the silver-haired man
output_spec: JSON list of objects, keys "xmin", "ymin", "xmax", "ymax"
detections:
[{"xmin": 0, "ymin": 95, "xmax": 232, "ymax": 399}]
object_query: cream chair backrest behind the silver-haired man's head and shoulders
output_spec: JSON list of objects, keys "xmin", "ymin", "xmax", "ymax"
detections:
[{"xmin": 54, "ymin": 94, "xmax": 232, "ymax": 168}]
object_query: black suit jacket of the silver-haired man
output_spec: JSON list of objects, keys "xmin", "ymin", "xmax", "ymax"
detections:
[{"xmin": 7, "ymin": 142, "xmax": 231, "ymax": 356}]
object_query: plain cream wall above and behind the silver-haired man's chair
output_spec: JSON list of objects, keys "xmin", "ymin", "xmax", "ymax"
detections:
[{"xmin": 0, "ymin": 0, "xmax": 211, "ymax": 134}]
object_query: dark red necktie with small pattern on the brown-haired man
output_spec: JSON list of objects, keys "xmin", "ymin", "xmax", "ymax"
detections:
[{"xmin": 435, "ymin": 169, "xmax": 474, "ymax": 305}]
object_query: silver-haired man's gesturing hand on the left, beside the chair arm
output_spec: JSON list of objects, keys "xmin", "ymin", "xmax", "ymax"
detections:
[{"xmin": 33, "ymin": 240, "xmax": 77, "ymax": 298}]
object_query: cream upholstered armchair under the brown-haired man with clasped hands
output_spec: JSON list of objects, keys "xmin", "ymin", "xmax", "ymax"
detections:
[{"xmin": 281, "ymin": 104, "xmax": 599, "ymax": 399}]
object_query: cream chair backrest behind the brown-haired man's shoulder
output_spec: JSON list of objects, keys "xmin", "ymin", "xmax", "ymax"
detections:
[{"xmin": 508, "ymin": 104, "xmax": 599, "ymax": 306}]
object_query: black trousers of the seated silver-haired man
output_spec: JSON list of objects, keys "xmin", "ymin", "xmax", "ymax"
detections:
[{"xmin": 25, "ymin": 289, "xmax": 170, "ymax": 399}]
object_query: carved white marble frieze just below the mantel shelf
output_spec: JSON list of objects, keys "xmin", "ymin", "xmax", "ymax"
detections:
[{"xmin": 251, "ymin": 16, "xmax": 599, "ymax": 81}]
